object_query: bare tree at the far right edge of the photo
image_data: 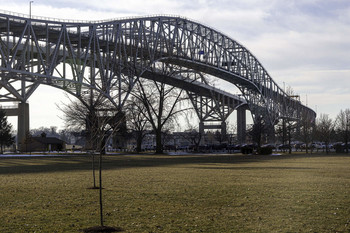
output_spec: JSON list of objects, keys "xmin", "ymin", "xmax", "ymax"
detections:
[{"xmin": 335, "ymin": 108, "xmax": 350, "ymax": 153}]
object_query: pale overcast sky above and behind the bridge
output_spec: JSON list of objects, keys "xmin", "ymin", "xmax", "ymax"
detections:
[{"xmin": 0, "ymin": 0, "xmax": 350, "ymax": 128}]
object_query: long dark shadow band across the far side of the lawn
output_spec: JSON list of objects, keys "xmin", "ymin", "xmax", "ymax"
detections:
[{"xmin": 0, "ymin": 154, "xmax": 349, "ymax": 174}]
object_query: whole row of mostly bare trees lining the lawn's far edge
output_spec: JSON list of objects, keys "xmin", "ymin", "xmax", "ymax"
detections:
[{"xmin": 0, "ymin": 79, "xmax": 350, "ymax": 154}]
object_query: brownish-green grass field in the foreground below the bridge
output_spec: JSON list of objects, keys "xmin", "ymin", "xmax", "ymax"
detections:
[{"xmin": 0, "ymin": 154, "xmax": 350, "ymax": 232}]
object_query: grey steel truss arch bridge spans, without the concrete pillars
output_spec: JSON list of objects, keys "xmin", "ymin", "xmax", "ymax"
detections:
[{"xmin": 0, "ymin": 12, "xmax": 316, "ymax": 146}]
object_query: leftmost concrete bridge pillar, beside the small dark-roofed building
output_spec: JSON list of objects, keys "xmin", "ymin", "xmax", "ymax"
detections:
[{"xmin": 17, "ymin": 103, "xmax": 29, "ymax": 149}]
